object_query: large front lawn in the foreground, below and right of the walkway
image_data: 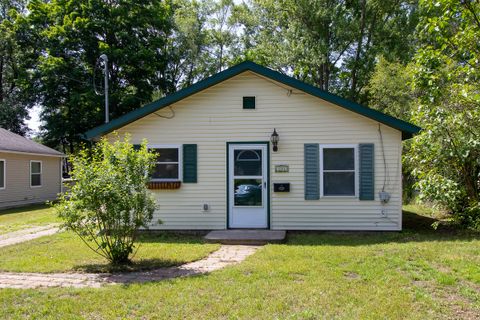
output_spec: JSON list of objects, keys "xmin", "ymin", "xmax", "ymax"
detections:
[{"xmin": 0, "ymin": 207, "xmax": 480, "ymax": 319}]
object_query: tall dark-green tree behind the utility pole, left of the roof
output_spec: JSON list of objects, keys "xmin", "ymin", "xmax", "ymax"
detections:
[{"xmin": 18, "ymin": 0, "xmax": 172, "ymax": 152}]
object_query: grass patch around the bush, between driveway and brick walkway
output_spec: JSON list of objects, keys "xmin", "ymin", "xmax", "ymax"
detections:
[{"xmin": 0, "ymin": 232, "xmax": 219, "ymax": 273}]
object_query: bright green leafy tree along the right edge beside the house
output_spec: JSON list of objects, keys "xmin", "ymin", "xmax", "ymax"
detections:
[{"xmin": 408, "ymin": 0, "xmax": 480, "ymax": 229}]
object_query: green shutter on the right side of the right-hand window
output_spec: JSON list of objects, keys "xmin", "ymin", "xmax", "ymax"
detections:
[{"xmin": 359, "ymin": 143, "xmax": 375, "ymax": 200}]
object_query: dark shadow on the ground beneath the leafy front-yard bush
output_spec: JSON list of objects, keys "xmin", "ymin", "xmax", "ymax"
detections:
[{"xmin": 73, "ymin": 258, "xmax": 184, "ymax": 273}]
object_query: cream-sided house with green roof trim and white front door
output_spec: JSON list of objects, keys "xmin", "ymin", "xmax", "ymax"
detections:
[{"xmin": 85, "ymin": 61, "xmax": 420, "ymax": 230}]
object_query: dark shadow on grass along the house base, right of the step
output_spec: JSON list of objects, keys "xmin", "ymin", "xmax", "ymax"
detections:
[{"xmin": 286, "ymin": 211, "xmax": 480, "ymax": 246}]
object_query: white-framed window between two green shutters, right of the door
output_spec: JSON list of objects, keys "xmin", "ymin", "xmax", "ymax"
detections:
[{"xmin": 320, "ymin": 145, "xmax": 357, "ymax": 196}]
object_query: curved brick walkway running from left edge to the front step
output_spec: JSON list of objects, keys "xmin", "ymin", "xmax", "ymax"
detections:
[{"xmin": 0, "ymin": 245, "xmax": 259, "ymax": 289}]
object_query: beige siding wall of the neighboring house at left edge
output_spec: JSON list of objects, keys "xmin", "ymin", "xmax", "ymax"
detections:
[{"xmin": 0, "ymin": 152, "xmax": 61, "ymax": 209}]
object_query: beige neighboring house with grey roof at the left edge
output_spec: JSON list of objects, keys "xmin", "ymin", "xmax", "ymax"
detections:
[{"xmin": 0, "ymin": 128, "xmax": 64, "ymax": 210}]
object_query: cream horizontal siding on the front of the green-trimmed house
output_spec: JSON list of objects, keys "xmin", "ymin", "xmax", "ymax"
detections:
[{"xmin": 110, "ymin": 72, "xmax": 401, "ymax": 230}]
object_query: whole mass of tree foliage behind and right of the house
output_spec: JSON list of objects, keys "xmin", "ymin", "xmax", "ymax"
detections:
[{"xmin": 0, "ymin": 0, "xmax": 480, "ymax": 228}]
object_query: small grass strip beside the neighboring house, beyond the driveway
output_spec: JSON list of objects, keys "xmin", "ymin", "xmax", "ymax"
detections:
[{"xmin": 0, "ymin": 204, "xmax": 60, "ymax": 234}]
